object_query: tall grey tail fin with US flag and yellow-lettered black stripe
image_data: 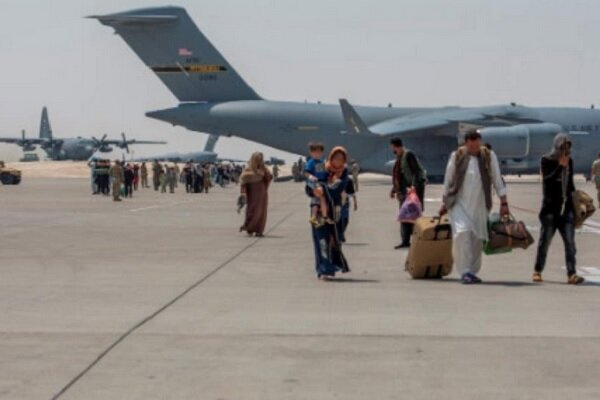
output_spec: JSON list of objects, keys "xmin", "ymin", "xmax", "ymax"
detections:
[{"xmin": 89, "ymin": 7, "xmax": 260, "ymax": 102}]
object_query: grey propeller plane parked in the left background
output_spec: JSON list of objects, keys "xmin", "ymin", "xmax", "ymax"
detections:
[{"xmin": 0, "ymin": 107, "xmax": 167, "ymax": 161}]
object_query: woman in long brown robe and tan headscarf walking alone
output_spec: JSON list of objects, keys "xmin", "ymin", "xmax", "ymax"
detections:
[{"xmin": 240, "ymin": 152, "xmax": 273, "ymax": 237}]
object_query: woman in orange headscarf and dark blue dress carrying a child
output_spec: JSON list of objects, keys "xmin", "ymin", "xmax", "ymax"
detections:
[{"xmin": 312, "ymin": 147, "xmax": 350, "ymax": 281}]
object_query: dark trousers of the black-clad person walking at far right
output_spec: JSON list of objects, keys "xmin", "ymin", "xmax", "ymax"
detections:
[{"xmin": 535, "ymin": 211, "xmax": 577, "ymax": 276}]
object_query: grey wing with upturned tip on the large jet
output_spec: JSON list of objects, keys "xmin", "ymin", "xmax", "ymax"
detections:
[{"xmin": 340, "ymin": 99, "xmax": 539, "ymax": 137}]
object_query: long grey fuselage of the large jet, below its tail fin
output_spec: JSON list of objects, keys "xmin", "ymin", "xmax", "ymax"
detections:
[{"xmin": 147, "ymin": 100, "xmax": 600, "ymax": 176}]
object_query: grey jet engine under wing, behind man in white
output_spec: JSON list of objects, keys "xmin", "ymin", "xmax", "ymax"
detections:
[{"xmin": 479, "ymin": 122, "xmax": 564, "ymax": 160}]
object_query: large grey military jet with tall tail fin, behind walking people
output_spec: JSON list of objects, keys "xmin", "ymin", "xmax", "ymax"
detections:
[{"xmin": 90, "ymin": 7, "xmax": 600, "ymax": 179}]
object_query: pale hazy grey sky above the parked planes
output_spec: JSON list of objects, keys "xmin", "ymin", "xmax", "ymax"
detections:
[{"xmin": 0, "ymin": 0, "xmax": 600, "ymax": 159}]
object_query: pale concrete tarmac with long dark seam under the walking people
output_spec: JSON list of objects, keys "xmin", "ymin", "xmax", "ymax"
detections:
[{"xmin": 0, "ymin": 176, "xmax": 600, "ymax": 400}]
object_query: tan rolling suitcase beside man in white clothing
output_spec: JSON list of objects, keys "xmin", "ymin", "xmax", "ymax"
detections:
[{"xmin": 405, "ymin": 217, "xmax": 454, "ymax": 279}]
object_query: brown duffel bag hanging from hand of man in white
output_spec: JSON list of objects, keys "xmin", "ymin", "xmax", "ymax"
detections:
[{"xmin": 483, "ymin": 215, "xmax": 535, "ymax": 255}]
